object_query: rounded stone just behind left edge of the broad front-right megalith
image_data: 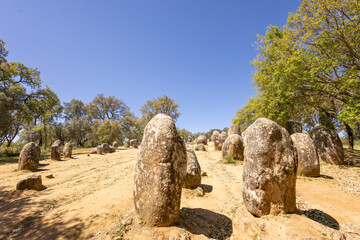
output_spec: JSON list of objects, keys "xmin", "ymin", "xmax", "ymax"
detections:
[{"xmin": 222, "ymin": 134, "xmax": 244, "ymax": 161}]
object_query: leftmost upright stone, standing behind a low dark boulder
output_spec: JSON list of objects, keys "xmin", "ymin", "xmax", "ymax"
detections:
[{"xmin": 18, "ymin": 142, "xmax": 39, "ymax": 171}]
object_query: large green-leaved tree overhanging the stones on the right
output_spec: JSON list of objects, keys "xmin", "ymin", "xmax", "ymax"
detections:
[{"xmin": 233, "ymin": 0, "xmax": 360, "ymax": 149}]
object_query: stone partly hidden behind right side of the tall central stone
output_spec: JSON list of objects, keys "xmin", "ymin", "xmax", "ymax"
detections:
[{"xmin": 183, "ymin": 146, "xmax": 201, "ymax": 188}]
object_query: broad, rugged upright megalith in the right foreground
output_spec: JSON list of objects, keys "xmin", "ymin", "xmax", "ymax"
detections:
[{"xmin": 243, "ymin": 118, "xmax": 297, "ymax": 216}]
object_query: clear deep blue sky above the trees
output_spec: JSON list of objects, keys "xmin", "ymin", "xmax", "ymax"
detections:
[{"xmin": 0, "ymin": 0, "xmax": 300, "ymax": 132}]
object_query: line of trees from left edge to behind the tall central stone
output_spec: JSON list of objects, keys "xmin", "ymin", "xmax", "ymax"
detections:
[{"xmin": 0, "ymin": 39, "xmax": 190, "ymax": 148}]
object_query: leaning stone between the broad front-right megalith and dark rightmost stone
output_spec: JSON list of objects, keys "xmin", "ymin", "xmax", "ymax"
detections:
[{"xmin": 291, "ymin": 133, "xmax": 320, "ymax": 177}]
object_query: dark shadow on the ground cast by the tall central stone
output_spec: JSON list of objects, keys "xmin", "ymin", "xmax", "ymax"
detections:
[{"xmin": 176, "ymin": 208, "xmax": 233, "ymax": 240}]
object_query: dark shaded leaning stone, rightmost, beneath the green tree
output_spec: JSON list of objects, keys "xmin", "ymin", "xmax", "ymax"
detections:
[{"xmin": 311, "ymin": 124, "xmax": 344, "ymax": 165}]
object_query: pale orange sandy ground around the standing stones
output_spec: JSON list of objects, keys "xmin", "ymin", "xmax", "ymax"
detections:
[{"xmin": 0, "ymin": 144, "xmax": 360, "ymax": 240}]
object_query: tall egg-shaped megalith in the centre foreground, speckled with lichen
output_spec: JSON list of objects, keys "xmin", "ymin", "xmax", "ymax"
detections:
[{"xmin": 134, "ymin": 114, "xmax": 186, "ymax": 227}]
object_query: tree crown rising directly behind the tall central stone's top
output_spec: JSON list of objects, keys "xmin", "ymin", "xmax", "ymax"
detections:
[{"xmin": 140, "ymin": 95, "xmax": 180, "ymax": 123}]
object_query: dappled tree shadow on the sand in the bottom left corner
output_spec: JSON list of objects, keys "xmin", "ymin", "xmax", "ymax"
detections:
[{"xmin": 0, "ymin": 187, "xmax": 89, "ymax": 239}]
